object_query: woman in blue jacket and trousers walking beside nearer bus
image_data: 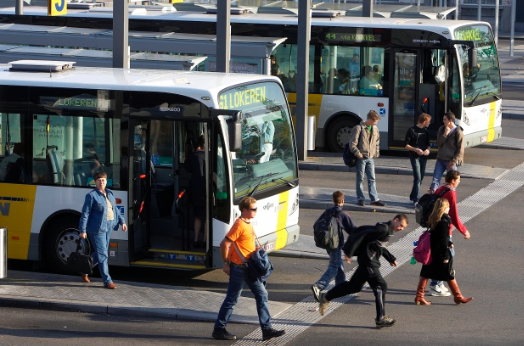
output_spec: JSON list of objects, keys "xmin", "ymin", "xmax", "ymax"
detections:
[{"xmin": 79, "ymin": 172, "xmax": 127, "ymax": 289}]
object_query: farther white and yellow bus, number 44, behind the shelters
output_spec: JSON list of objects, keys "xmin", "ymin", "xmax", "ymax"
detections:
[{"xmin": 0, "ymin": 0, "xmax": 502, "ymax": 151}]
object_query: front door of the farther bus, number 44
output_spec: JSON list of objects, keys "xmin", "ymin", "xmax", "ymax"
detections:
[{"xmin": 388, "ymin": 49, "xmax": 419, "ymax": 147}]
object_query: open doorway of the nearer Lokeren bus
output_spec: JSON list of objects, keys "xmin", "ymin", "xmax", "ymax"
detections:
[{"xmin": 130, "ymin": 119, "xmax": 211, "ymax": 269}]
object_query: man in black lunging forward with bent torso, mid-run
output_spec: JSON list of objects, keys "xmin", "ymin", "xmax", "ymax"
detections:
[{"xmin": 319, "ymin": 214, "xmax": 408, "ymax": 328}]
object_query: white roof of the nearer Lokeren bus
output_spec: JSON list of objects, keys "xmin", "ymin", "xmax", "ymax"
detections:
[{"xmin": 0, "ymin": 64, "xmax": 280, "ymax": 106}]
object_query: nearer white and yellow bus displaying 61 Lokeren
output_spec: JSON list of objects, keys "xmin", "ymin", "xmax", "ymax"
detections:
[{"xmin": 0, "ymin": 61, "xmax": 300, "ymax": 271}]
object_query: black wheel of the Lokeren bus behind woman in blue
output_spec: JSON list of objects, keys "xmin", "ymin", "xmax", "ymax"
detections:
[{"xmin": 44, "ymin": 216, "xmax": 90, "ymax": 274}]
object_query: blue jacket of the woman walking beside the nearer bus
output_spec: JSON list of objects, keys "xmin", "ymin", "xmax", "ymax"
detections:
[{"xmin": 78, "ymin": 189, "xmax": 125, "ymax": 234}]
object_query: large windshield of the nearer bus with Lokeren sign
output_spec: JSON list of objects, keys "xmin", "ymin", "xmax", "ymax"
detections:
[{"xmin": 220, "ymin": 82, "xmax": 298, "ymax": 199}]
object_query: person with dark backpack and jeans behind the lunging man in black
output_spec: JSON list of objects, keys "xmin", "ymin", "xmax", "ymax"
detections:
[{"xmin": 311, "ymin": 191, "xmax": 356, "ymax": 302}]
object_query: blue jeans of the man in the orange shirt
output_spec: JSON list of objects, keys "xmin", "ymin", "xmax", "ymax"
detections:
[{"xmin": 215, "ymin": 265, "xmax": 271, "ymax": 329}]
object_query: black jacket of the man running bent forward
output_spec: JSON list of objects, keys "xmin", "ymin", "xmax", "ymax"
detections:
[{"xmin": 342, "ymin": 221, "xmax": 397, "ymax": 268}]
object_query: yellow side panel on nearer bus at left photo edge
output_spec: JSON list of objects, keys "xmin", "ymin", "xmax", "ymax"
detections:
[{"xmin": 0, "ymin": 184, "xmax": 36, "ymax": 260}]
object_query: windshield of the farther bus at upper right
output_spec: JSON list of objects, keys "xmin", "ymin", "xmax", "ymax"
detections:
[{"xmin": 455, "ymin": 25, "xmax": 501, "ymax": 107}]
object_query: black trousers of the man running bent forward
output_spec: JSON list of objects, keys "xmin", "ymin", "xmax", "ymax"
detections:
[{"xmin": 326, "ymin": 266, "xmax": 388, "ymax": 320}]
